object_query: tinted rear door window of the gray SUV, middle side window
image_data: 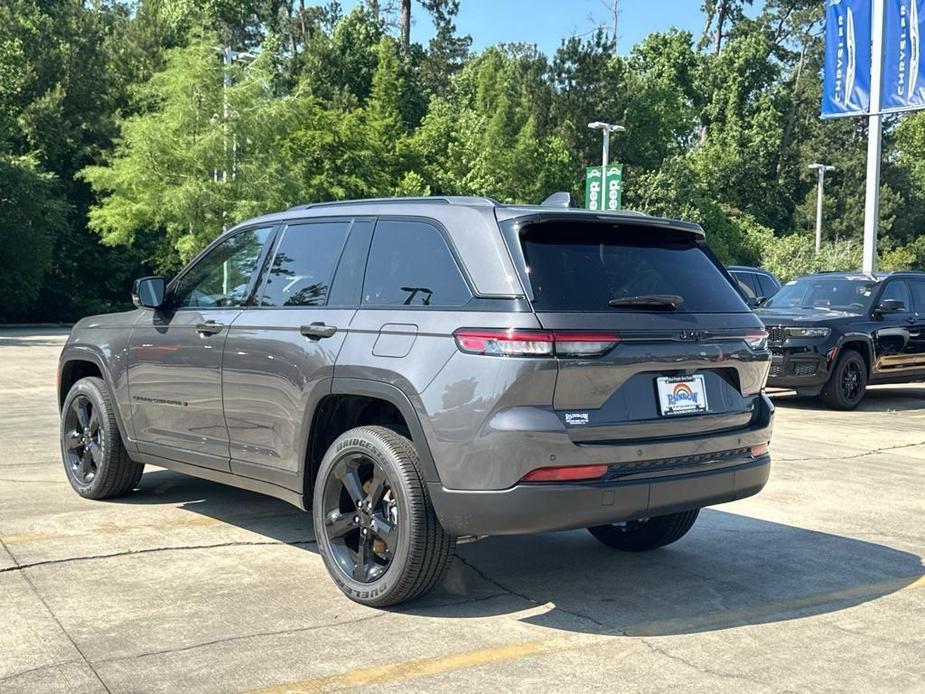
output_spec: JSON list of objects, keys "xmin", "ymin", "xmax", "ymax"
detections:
[{"xmin": 260, "ymin": 220, "xmax": 350, "ymax": 306}]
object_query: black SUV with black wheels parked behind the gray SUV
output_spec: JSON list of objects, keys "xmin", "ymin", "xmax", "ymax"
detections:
[{"xmin": 756, "ymin": 272, "xmax": 925, "ymax": 410}]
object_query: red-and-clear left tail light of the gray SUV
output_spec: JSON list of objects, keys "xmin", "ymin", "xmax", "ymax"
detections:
[{"xmin": 453, "ymin": 328, "xmax": 620, "ymax": 357}]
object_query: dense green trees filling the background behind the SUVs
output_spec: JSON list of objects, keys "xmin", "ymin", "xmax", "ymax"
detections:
[{"xmin": 0, "ymin": 0, "xmax": 925, "ymax": 320}]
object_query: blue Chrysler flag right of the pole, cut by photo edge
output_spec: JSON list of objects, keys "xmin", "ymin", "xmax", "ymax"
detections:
[{"xmin": 881, "ymin": 0, "xmax": 925, "ymax": 111}]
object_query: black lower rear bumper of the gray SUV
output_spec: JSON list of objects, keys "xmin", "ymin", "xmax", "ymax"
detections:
[{"xmin": 428, "ymin": 455, "xmax": 771, "ymax": 535}]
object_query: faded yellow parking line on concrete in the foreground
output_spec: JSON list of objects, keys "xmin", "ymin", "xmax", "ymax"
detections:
[{"xmin": 250, "ymin": 574, "xmax": 925, "ymax": 694}]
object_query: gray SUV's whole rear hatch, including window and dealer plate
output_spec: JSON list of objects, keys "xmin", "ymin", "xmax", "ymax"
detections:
[{"xmin": 502, "ymin": 213, "xmax": 769, "ymax": 443}]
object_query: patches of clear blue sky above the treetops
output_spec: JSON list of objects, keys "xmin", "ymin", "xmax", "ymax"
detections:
[{"xmin": 330, "ymin": 0, "xmax": 760, "ymax": 55}]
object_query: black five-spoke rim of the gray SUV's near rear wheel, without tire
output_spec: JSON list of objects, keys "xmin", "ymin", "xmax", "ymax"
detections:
[{"xmin": 323, "ymin": 453, "xmax": 400, "ymax": 583}]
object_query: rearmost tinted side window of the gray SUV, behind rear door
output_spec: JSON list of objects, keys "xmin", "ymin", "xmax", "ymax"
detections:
[{"xmin": 363, "ymin": 220, "xmax": 472, "ymax": 306}]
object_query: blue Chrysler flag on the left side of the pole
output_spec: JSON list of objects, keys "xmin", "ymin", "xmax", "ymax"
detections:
[{"xmin": 822, "ymin": 0, "xmax": 871, "ymax": 118}]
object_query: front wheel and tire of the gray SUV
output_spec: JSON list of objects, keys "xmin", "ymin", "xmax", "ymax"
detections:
[{"xmin": 61, "ymin": 377, "xmax": 144, "ymax": 499}]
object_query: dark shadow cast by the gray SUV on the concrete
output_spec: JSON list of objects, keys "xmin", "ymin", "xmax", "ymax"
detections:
[{"xmin": 122, "ymin": 470, "xmax": 925, "ymax": 636}]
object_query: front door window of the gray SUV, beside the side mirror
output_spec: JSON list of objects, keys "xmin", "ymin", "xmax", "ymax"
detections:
[{"xmin": 170, "ymin": 228, "xmax": 273, "ymax": 308}]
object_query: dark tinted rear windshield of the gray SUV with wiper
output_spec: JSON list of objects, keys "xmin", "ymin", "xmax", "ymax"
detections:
[{"xmin": 520, "ymin": 223, "xmax": 749, "ymax": 313}]
